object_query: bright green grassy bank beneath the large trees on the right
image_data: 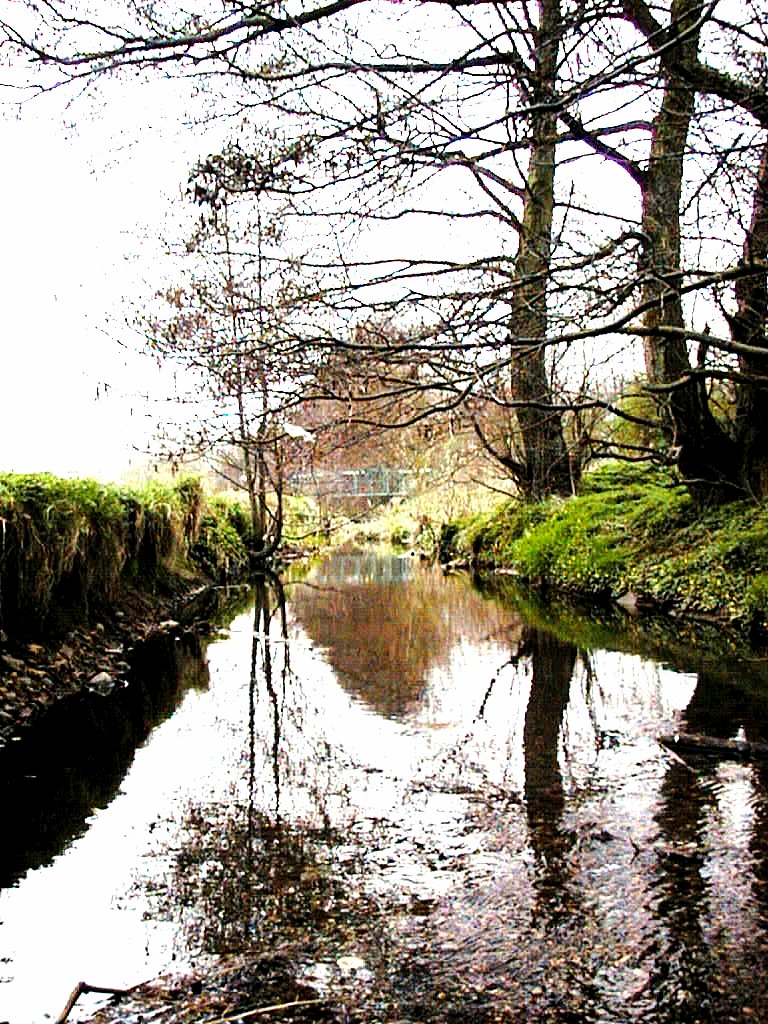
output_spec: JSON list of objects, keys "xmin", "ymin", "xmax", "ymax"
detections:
[{"xmin": 440, "ymin": 466, "xmax": 768, "ymax": 629}]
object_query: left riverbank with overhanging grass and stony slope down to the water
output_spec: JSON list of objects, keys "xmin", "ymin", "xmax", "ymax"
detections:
[{"xmin": 0, "ymin": 474, "xmax": 259, "ymax": 746}]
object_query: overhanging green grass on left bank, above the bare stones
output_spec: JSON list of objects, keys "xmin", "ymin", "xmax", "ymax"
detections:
[{"xmin": 0, "ymin": 474, "xmax": 259, "ymax": 637}]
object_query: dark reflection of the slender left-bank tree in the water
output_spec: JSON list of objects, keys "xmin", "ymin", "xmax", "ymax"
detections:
[{"xmin": 168, "ymin": 573, "xmax": 348, "ymax": 953}]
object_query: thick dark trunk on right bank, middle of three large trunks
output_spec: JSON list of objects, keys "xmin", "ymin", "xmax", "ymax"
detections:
[{"xmin": 628, "ymin": 0, "xmax": 738, "ymax": 502}]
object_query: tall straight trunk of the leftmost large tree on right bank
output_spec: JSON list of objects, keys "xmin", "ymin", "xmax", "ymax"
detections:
[{"xmin": 509, "ymin": 0, "xmax": 571, "ymax": 499}]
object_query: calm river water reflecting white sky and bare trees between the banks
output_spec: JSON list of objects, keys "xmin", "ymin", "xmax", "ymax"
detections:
[{"xmin": 0, "ymin": 552, "xmax": 768, "ymax": 1024}]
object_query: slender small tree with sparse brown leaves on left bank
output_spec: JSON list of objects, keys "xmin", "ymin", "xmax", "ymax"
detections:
[{"xmin": 143, "ymin": 160, "xmax": 319, "ymax": 561}]
